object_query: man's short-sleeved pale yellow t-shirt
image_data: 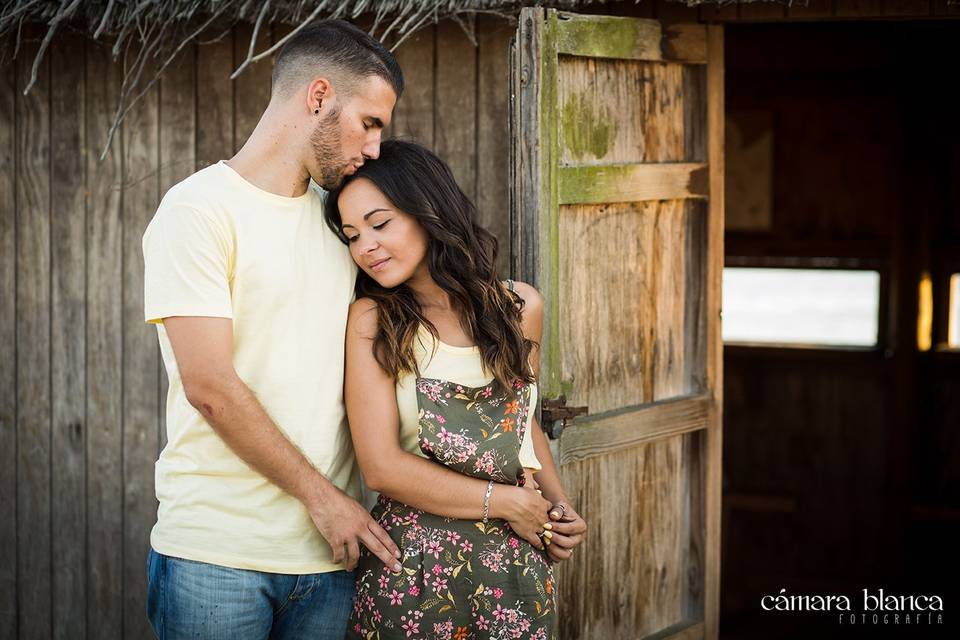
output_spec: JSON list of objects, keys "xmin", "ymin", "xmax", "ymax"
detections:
[{"xmin": 143, "ymin": 162, "xmax": 359, "ymax": 574}]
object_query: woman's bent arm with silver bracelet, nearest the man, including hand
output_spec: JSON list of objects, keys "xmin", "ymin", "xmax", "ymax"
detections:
[{"xmin": 344, "ymin": 298, "xmax": 550, "ymax": 547}]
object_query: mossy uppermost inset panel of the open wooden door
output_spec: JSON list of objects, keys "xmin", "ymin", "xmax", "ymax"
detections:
[{"xmin": 557, "ymin": 57, "xmax": 687, "ymax": 165}]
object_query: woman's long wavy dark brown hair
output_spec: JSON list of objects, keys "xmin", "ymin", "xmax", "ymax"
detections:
[{"xmin": 324, "ymin": 140, "xmax": 535, "ymax": 390}]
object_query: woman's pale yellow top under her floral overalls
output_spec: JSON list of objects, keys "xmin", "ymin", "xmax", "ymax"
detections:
[{"xmin": 396, "ymin": 326, "xmax": 542, "ymax": 471}]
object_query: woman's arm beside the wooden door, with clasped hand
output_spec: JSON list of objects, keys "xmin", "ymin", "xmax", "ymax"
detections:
[{"xmin": 515, "ymin": 282, "xmax": 587, "ymax": 560}]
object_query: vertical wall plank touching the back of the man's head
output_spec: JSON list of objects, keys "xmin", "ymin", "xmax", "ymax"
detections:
[{"xmin": 231, "ymin": 24, "xmax": 273, "ymax": 153}]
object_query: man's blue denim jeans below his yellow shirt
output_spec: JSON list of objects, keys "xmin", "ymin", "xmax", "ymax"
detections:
[{"xmin": 147, "ymin": 549, "xmax": 353, "ymax": 640}]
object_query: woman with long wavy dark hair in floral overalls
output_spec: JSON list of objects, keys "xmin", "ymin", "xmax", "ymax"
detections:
[{"xmin": 326, "ymin": 141, "xmax": 586, "ymax": 639}]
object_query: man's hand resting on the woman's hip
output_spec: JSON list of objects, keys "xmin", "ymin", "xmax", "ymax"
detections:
[{"xmin": 307, "ymin": 485, "xmax": 400, "ymax": 572}]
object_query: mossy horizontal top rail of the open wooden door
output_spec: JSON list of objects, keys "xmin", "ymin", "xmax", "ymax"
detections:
[{"xmin": 557, "ymin": 12, "xmax": 707, "ymax": 64}]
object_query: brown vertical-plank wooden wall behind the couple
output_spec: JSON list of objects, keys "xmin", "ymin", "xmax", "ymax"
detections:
[{"xmin": 0, "ymin": 18, "xmax": 514, "ymax": 639}]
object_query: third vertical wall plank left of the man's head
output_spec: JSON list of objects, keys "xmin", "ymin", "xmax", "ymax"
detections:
[{"xmin": 158, "ymin": 46, "xmax": 197, "ymax": 452}]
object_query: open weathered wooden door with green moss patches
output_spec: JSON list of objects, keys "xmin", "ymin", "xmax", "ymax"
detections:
[{"xmin": 511, "ymin": 8, "xmax": 723, "ymax": 639}]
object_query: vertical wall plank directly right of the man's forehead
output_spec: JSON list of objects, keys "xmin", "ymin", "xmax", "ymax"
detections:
[{"xmin": 387, "ymin": 27, "xmax": 437, "ymax": 149}]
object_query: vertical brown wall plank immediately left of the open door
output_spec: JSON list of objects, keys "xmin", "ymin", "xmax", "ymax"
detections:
[{"xmin": 476, "ymin": 16, "xmax": 515, "ymax": 276}]
